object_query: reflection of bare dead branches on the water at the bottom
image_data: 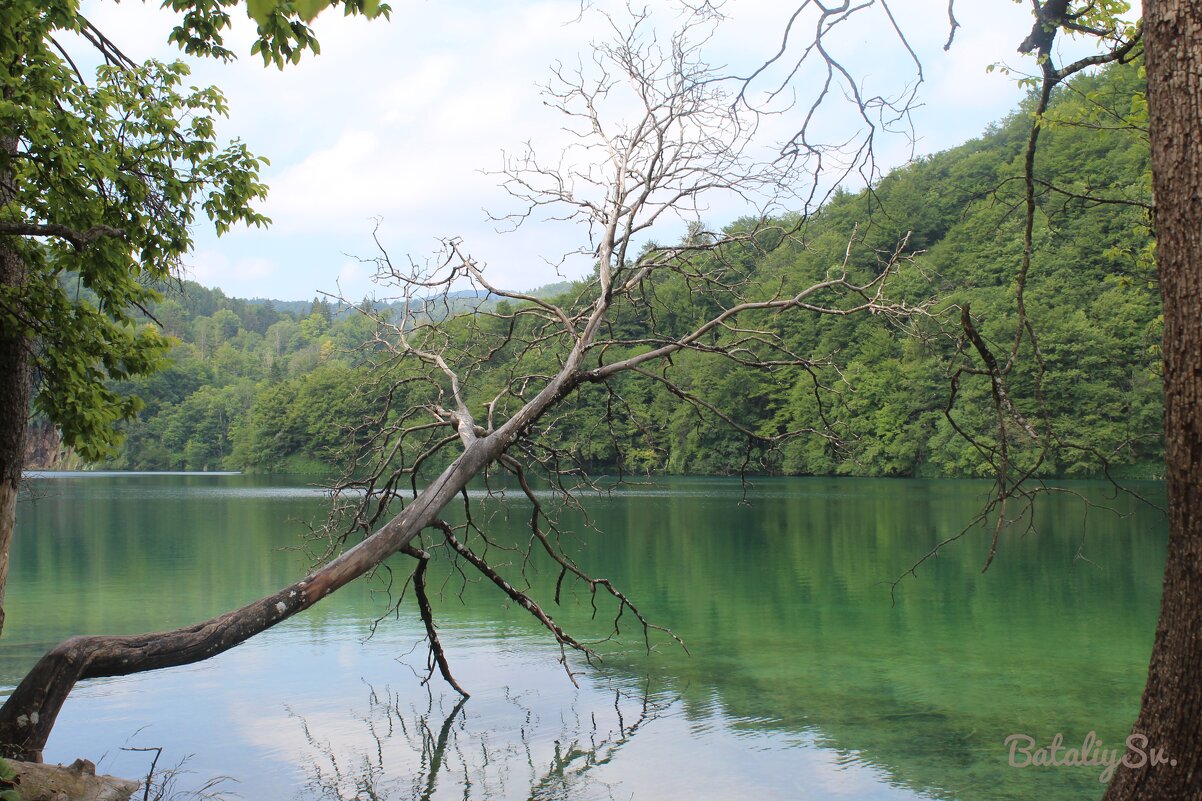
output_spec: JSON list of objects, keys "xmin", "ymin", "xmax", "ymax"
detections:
[{"xmin": 294, "ymin": 687, "xmax": 679, "ymax": 801}]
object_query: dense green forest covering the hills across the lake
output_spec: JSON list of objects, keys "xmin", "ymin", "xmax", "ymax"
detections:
[{"xmin": 82, "ymin": 60, "xmax": 1162, "ymax": 476}]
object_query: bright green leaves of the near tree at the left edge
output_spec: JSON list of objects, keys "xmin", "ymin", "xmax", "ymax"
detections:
[{"xmin": 0, "ymin": 0, "xmax": 282, "ymax": 459}]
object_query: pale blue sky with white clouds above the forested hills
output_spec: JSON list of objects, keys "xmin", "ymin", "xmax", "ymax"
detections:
[{"xmin": 77, "ymin": 0, "xmax": 1134, "ymax": 299}]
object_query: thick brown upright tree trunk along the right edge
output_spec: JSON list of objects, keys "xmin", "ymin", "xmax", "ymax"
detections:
[{"xmin": 1105, "ymin": 0, "xmax": 1202, "ymax": 801}]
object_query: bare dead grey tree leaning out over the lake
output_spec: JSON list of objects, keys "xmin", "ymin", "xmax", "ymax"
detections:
[{"xmin": 0, "ymin": 3, "xmax": 927, "ymax": 759}]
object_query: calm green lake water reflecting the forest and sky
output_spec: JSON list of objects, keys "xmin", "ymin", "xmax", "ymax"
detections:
[{"xmin": 0, "ymin": 475, "xmax": 1166, "ymax": 801}]
